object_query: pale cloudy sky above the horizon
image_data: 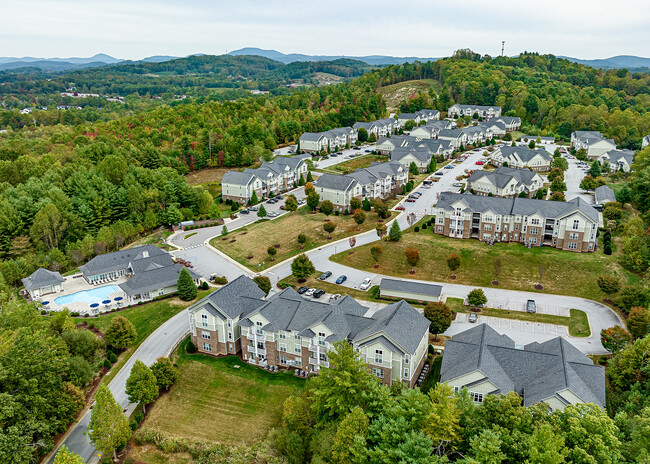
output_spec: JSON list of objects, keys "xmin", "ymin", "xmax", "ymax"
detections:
[{"xmin": 0, "ymin": 0, "xmax": 650, "ymax": 59}]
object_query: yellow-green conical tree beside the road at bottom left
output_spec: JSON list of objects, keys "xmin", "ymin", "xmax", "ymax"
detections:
[{"xmin": 88, "ymin": 384, "xmax": 131, "ymax": 459}]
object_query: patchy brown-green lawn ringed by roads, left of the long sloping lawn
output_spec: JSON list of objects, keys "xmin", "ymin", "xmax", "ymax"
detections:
[{"xmin": 210, "ymin": 206, "xmax": 384, "ymax": 270}]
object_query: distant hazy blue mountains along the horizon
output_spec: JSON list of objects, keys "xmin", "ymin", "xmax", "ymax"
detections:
[{"xmin": 0, "ymin": 47, "xmax": 650, "ymax": 71}]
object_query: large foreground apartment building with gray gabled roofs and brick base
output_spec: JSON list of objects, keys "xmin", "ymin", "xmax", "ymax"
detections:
[{"xmin": 189, "ymin": 276, "xmax": 429, "ymax": 387}]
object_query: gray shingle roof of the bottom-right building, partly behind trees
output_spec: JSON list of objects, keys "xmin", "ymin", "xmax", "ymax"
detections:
[{"xmin": 440, "ymin": 324, "xmax": 605, "ymax": 407}]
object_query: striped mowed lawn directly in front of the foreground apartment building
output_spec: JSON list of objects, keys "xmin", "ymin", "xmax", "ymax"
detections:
[{"xmin": 144, "ymin": 340, "xmax": 305, "ymax": 444}]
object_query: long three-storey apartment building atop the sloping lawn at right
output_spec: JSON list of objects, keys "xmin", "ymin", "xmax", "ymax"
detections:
[{"xmin": 435, "ymin": 192, "xmax": 599, "ymax": 252}]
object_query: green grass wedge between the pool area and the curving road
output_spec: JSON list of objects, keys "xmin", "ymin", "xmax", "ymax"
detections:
[{"xmin": 74, "ymin": 290, "xmax": 213, "ymax": 383}]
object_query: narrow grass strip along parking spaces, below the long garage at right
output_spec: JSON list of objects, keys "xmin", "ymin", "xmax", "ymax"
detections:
[{"xmin": 447, "ymin": 298, "xmax": 591, "ymax": 337}]
